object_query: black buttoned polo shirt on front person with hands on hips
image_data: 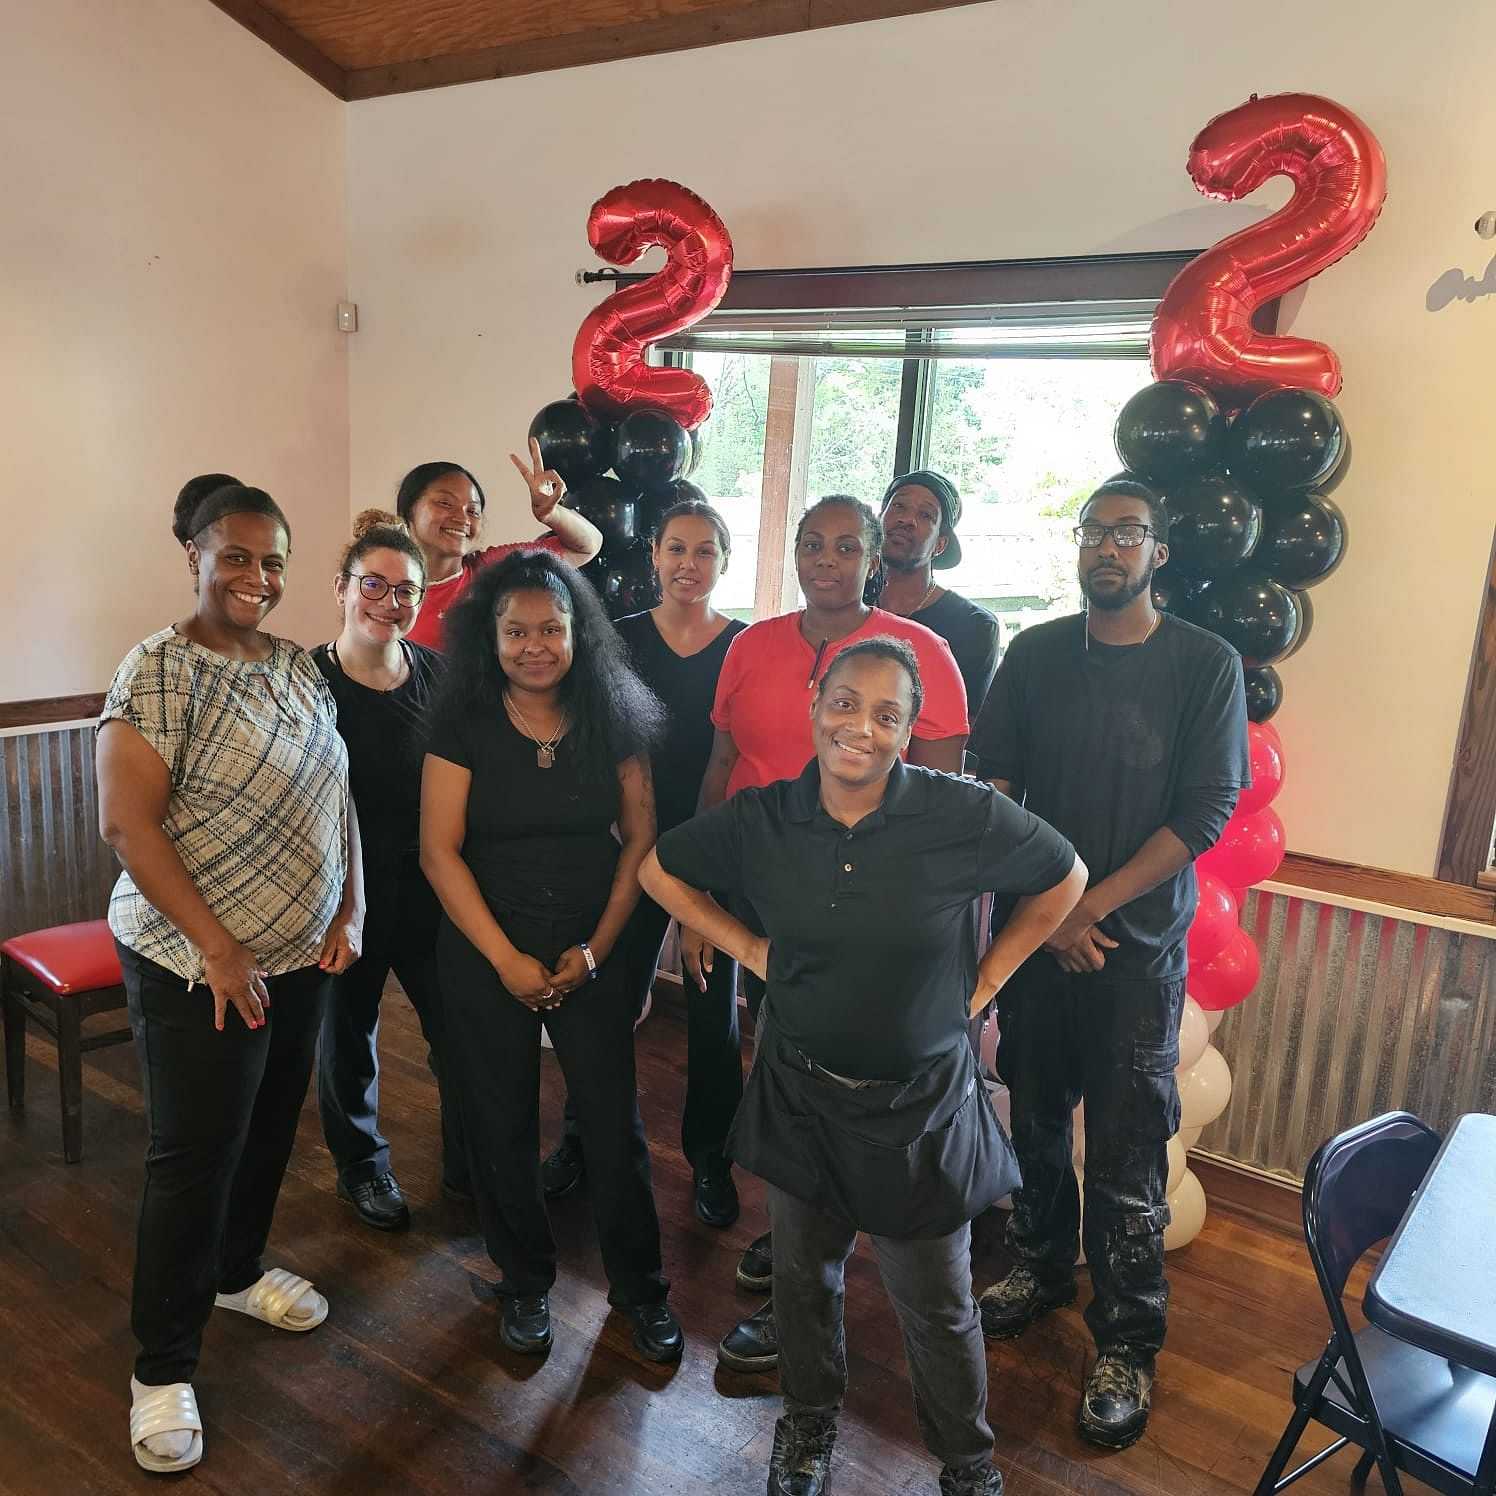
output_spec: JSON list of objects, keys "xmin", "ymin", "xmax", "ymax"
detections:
[{"xmin": 655, "ymin": 758, "xmax": 1076, "ymax": 1080}]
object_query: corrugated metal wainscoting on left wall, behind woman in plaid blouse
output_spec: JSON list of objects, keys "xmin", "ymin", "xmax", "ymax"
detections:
[{"xmin": 0, "ymin": 724, "xmax": 120, "ymax": 939}]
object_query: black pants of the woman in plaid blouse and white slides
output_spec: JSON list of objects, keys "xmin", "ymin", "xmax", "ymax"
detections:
[{"xmin": 118, "ymin": 945, "xmax": 332, "ymax": 1387}]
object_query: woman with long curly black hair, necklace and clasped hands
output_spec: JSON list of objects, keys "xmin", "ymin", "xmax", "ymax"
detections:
[{"xmin": 420, "ymin": 552, "xmax": 682, "ymax": 1361}]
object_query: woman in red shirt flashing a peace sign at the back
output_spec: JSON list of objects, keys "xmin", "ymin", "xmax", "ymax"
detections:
[{"xmin": 395, "ymin": 437, "xmax": 603, "ymax": 649}]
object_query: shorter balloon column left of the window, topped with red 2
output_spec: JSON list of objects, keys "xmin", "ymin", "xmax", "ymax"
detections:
[{"xmin": 530, "ymin": 181, "xmax": 733, "ymax": 618}]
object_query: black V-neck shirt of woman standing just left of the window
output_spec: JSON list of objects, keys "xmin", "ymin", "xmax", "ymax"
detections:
[{"xmin": 615, "ymin": 613, "xmax": 748, "ymax": 832}]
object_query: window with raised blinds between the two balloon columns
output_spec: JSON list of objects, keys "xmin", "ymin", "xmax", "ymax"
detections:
[{"xmin": 664, "ymin": 256, "xmax": 1188, "ymax": 642}]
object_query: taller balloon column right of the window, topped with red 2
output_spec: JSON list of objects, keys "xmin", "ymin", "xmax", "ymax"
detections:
[{"xmin": 1116, "ymin": 94, "xmax": 1387, "ymax": 1248}]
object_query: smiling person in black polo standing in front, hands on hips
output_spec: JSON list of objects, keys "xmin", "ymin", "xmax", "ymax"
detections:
[{"xmin": 640, "ymin": 639, "xmax": 1086, "ymax": 1496}]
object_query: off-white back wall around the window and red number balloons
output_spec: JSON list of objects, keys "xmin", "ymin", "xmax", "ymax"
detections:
[{"xmin": 349, "ymin": 0, "xmax": 1496, "ymax": 872}]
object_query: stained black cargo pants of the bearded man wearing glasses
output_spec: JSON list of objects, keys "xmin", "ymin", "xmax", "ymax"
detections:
[{"xmin": 998, "ymin": 951, "xmax": 1185, "ymax": 1366}]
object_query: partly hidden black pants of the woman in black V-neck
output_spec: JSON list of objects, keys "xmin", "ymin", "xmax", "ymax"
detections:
[{"xmin": 565, "ymin": 893, "xmax": 748, "ymax": 1170}]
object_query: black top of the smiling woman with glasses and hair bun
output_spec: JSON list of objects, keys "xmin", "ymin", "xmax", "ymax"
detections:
[{"xmin": 311, "ymin": 642, "xmax": 444, "ymax": 910}]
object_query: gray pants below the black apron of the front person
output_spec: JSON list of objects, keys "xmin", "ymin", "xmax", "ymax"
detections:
[{"xmin": 769, "ymin": 1185, "xmax": 992, "ymax": 1468}]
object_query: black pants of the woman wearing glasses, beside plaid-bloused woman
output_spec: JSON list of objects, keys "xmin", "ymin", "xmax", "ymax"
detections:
[{"xmin": 317, "ymin": 871, "xmax": 467, "ymax": 1189}]
